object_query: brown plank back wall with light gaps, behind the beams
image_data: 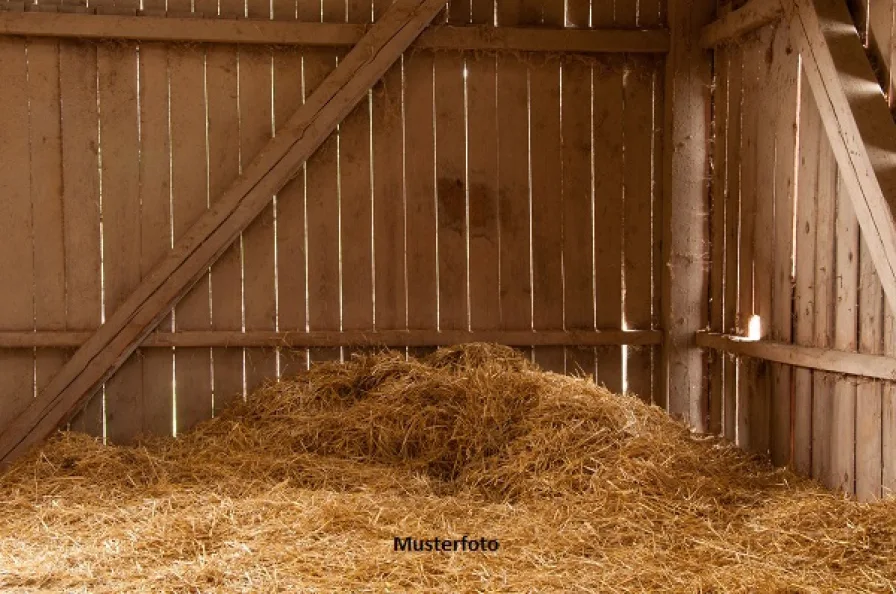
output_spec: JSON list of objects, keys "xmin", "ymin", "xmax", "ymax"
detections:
[{"xmin": 0, "ymin": 0, "xmax": 664, "ymax": 442}]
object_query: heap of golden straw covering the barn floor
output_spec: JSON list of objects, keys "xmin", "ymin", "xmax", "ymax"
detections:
[{"xmin": 0, "ymin": 345, "xmax": 896, "ymax": 592}]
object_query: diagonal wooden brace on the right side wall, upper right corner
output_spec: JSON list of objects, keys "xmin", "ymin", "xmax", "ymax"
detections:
[{"xmin": 780, "ymin": 0, "xmax": 896, "ymax": 311}]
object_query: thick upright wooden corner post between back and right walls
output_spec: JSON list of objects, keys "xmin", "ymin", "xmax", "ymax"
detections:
[{"xmin": 662, "ymin": 0, "xmax": 715, "ymax": 431}]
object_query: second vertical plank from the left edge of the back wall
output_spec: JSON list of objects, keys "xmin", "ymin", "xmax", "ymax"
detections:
[{"xmin": 28, "ymin": 39, "xmax": 69, "ymax": 420}]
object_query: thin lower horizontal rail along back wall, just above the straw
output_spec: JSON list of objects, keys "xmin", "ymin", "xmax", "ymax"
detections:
[{"xmin": 0, "ymin": 330, "xmax": 663, "ymax": 349}]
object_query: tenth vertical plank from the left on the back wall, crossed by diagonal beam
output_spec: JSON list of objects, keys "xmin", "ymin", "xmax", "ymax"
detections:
[{"xmin": 304, "ymin": 49, "xmax": 342, "ymax": 362}]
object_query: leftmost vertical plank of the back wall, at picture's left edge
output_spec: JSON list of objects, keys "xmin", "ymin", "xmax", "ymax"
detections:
[{"xmin": 0, "ymin": 38, "xmax": 34, "ymax": 427}]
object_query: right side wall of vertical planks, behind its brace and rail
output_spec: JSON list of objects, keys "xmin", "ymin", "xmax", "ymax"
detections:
[{"xmin": 709, "ymin": 0, "xmax": 896, "ymax": 499}]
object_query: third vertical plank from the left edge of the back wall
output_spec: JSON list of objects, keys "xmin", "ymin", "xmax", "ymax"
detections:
[{"xmin": 60, "ymin": 42, "xmax": 103, "ymax": 436}]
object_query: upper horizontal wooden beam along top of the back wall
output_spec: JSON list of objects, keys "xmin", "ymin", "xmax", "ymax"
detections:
[{"xmin": 0, "ymin": 12, "xmax": 669, "ymax": 54}]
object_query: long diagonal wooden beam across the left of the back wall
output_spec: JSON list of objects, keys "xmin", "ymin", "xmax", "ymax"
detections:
[{"xmin": 0, "ymin": 0, "xmax": 445, "ymax": 465}]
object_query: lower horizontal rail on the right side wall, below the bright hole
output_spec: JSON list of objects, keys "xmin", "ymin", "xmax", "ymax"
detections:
[{"xmin": 697, "ymin": 332, "xmax": 896, "ymax": 381}]
